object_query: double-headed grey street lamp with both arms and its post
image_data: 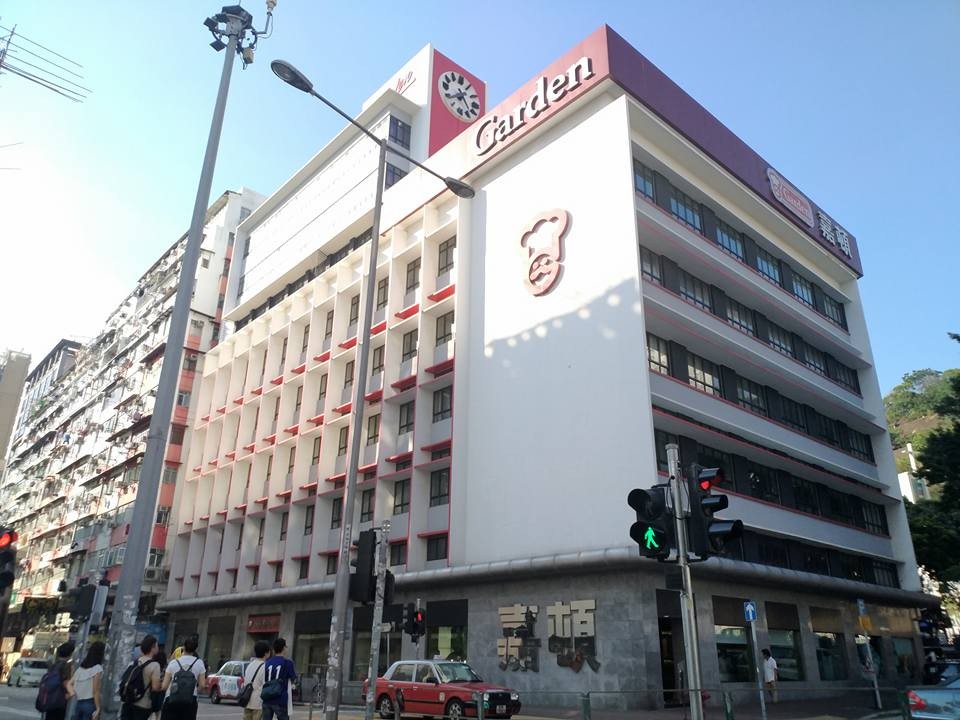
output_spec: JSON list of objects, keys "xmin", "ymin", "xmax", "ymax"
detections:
[{"xmin": 270, "ymin": 60, "xmax": 474, "ymax": 720}]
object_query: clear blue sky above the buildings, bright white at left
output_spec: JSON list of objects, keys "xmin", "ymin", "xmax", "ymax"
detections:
[{"xmin": 0, "ymin": 0, "xmax": 960, "ymax": 392}]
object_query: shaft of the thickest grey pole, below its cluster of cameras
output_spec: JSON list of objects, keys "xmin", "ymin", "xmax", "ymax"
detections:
[{"xmin": 100, "ymin": 15, "xmax": 243, "ymax": 720}]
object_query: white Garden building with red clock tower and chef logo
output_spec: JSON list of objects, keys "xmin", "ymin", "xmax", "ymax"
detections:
[{"xmin": 165, "ymin": 27, "xmax": 929, "ymax": 704}]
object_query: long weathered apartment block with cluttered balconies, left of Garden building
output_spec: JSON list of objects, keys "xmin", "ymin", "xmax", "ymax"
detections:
[{"xmin": 0, "ymin": 190, "xmax": 262, "ymax": 636}]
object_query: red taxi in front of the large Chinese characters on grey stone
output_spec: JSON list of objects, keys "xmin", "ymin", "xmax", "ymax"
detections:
[{"xmin": 363, "ymin": 660, "xmax": 520, "ymax": 720}]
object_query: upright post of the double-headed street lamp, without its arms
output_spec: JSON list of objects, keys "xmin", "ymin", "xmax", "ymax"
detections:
[{"xmin": 324, "ymin": 138, "xmax": 387, "ymax": 720}]
